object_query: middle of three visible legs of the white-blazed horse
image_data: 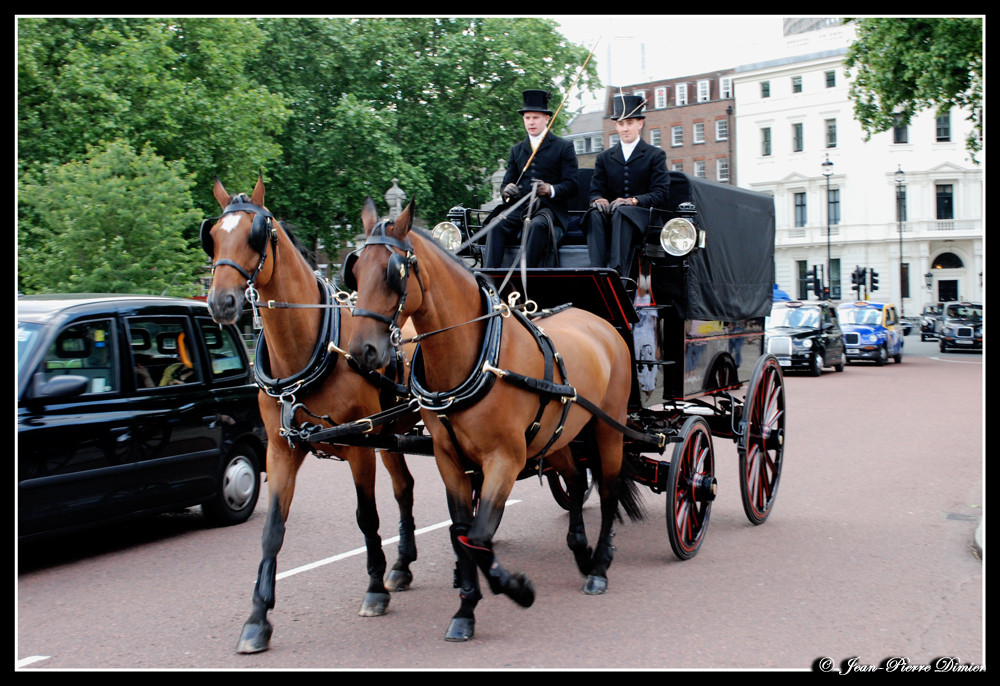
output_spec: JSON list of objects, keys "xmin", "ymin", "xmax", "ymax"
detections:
[{"xmin": 347, "ymin": 449, "xmax": 389, "ymax": 617}]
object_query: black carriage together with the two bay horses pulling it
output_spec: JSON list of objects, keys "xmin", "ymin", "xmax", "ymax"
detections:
[{"xmin": 201, "ymin": 170, "xmax": 785, "ymax": 652}]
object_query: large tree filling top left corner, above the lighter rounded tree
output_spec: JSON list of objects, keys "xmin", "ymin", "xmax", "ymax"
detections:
[{"xmin": 17, "ymin": 17, "xmax": 289, "ymax": 215}]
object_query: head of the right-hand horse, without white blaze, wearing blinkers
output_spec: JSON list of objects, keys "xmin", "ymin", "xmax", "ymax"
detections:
[{"xmin": 343, "ymin": 198, "xmax": 422, "ymax": 369}]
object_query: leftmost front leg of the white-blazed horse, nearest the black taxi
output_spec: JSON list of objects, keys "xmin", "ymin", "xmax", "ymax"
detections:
[{"xmin": 236, "ymin": 441, "xmax": 305, "ymax": 653}]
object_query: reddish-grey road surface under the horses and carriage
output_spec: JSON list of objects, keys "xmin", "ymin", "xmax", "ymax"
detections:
[{"xmin": 16, "ymin": 335, "xmax": 985, "ymax": 671}]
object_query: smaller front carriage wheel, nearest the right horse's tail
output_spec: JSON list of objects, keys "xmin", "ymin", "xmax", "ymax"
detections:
[{"xmin": 667, "ymin": 417, "xmax": 716, "ymax": 560}]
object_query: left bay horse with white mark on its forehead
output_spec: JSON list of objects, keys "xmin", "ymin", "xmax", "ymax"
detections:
[{"xmin": 201, "ymin": 177, "xmax": 417, "ymax": 653}]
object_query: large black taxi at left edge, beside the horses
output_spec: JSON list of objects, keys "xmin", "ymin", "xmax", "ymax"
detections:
[{"xmin": 17, "ymin": 295, "xmax": 267, "ymax": 538}]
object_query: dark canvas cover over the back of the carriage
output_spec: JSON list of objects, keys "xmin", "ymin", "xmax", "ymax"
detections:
[{"xmin": 670, "ymin": 172, "xmax": 775, "ymax": 321}]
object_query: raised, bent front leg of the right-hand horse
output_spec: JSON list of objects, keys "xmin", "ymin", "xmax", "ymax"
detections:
[{"xmin": 458, "ymin": 459, "xmax": 535, "ymax": 607}]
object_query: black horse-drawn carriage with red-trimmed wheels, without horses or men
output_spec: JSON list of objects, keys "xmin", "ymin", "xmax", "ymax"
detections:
[{"xmin": 432, "ymin": 169, "xmax": 785, "ymax": 559}]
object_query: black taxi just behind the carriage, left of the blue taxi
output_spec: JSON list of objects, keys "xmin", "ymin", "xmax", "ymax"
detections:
[{"xmin": 764, "ymin": 300, "xmax": 847, "ymax": 376}]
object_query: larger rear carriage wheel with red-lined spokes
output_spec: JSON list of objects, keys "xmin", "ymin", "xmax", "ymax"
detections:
[{"xmin": 738, "ymin": 355, "xmax": 785, "ymax": 524}]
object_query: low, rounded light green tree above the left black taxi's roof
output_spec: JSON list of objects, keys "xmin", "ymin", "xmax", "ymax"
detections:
[{"xmin": 18, "ymin": 140, "xmax": 205, "ymax": 296}]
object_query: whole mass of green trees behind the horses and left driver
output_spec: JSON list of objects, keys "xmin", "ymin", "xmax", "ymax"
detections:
[{"xmin": 17, "ymin": 17, "xmax": 600, "ymax": 292}]
